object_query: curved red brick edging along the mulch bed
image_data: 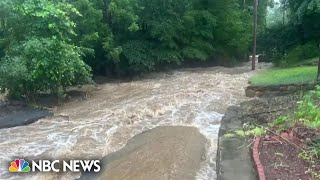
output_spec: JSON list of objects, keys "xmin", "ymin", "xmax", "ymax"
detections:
[{"xmin": 252, "ymin": 137, "xmax": 266, "ymax": 180}]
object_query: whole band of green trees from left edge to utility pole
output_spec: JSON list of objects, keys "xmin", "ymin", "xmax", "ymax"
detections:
[{"xmin": 0, "ymin": 0, "xmax": 267, "ymax": 100}]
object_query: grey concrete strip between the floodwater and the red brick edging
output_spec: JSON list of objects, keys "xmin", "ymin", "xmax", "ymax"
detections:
[{"xmin": 216, "ymin": 106, "xmax": 257, "ymax": 180}]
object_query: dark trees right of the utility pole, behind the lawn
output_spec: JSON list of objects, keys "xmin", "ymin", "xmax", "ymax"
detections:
[{"xmin": 258, "ymin": 0, "xmax": 320, "ymax": 66}]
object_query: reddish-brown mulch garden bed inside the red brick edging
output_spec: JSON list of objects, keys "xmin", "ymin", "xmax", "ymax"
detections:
[{"xmin": 258, "ymin": 130, "xmax": 320, "ymax": 180}]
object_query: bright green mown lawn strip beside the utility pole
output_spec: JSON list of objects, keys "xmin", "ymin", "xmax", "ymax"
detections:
[{"xmin": 249, "ymin": 66, "xmax": 317, "ymax": 86}]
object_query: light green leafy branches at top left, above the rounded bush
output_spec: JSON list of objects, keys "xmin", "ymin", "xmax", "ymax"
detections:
[{"xmin": 14, "ymin": 0, "xmax": 81, "ymax": 40}]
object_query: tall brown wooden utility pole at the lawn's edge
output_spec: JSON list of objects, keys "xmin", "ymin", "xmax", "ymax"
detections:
[{"xmin": 252, "ymin": 0, "xmax": 258, "ymax": 70}]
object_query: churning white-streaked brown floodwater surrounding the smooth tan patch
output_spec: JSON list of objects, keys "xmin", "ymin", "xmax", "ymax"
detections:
[{"xmin": 0, "ymin": 66, "xmax": 255, "ymax": 179}]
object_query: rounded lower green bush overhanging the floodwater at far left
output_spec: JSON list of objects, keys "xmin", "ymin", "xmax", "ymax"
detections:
[{"xmin": 0, "ymin": 37, "xmax": 91, "ymax": 98}]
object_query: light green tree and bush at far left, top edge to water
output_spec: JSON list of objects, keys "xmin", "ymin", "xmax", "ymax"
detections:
[{"xmin": 0, "ymin": 0, "xmax": 92, "ymax": 98}]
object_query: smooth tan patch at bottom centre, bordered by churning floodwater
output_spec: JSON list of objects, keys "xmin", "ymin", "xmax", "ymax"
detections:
[{"xmin": 80, "ymin": 127, "xmax": 206, "ymax": 180}]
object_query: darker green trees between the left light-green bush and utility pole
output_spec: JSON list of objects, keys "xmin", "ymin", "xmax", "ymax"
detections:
[{"xmin": 70, "ymin": 0, "xmax": 251, "ymax": 72}]
